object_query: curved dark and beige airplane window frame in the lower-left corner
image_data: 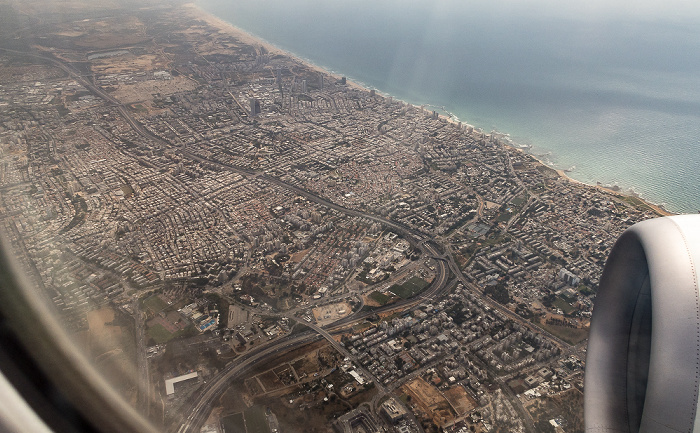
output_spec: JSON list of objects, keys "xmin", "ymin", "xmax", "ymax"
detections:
[{"xmin": 0, "ymin": 233, "xmax": 157, "ymax": 433}]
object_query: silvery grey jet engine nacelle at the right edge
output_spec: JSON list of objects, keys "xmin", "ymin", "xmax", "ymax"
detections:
[{"xmin": 584, "ymin": 215, "xmax": 700, "ymax": 433}]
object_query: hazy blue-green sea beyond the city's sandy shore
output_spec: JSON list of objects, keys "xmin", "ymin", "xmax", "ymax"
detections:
[{"xmin": 196, "ymin": 0, "xmax": 700, "ymax": 213}]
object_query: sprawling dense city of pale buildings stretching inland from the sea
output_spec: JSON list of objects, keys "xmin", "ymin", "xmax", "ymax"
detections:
[{"xmin": 0, "ymin": 2, "xmax": 664, "ymax": 433}]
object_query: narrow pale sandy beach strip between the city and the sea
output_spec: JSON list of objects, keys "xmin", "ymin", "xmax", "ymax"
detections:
[{"xmin": 182, "ymin": 3, "xmax": 676, "ymax": 216}]
